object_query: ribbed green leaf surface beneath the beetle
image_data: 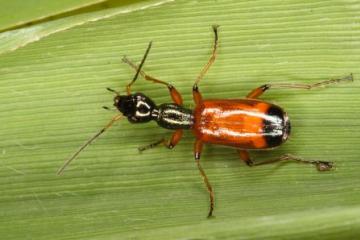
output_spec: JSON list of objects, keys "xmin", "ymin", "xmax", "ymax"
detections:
[{"xmin": 0, "ymin": 0, "xmax": 360, "ymax": 240}]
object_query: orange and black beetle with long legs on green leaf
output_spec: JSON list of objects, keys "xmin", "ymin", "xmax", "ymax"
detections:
[{"xmin": 57, "ymin": 25, "xmax": 353, "ymax": 217}]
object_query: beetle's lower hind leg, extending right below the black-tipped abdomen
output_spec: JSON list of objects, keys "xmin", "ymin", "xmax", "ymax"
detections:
[{"xmin": 238, "ymin": 150, "xmax": 333, "ymax": 171}]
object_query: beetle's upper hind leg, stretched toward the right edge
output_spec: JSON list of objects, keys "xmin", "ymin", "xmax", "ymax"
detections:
[{"xmin": 246, "ymin": 73, "xmax": 353, "ymax": 98}]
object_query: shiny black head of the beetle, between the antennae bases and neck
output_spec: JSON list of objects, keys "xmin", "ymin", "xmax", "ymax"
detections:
[{"xmin": 114, "ymin": 93, "xmax": 156, "ymax": 123}]
